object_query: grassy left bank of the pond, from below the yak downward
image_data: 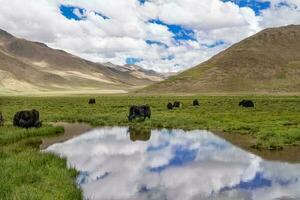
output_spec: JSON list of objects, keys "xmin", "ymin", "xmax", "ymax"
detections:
[{"xmin": 0, "ymin": 125, "xmax": 81, "ymax": 200}]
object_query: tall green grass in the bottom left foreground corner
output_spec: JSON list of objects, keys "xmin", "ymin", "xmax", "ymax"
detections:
[{"xmin": 0, "ymin": 145, "xmax": 81, "ymax": 200}]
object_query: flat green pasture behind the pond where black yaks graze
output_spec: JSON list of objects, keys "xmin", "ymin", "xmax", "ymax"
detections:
[{"xmin": 0, "ymin": 96, "xmax": 300, "ymax": 147}]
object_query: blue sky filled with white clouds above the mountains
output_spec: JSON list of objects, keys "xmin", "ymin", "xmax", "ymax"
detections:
[{"xmin": 0, "ymin": 0, "xmax": 300, "ymax": 72}]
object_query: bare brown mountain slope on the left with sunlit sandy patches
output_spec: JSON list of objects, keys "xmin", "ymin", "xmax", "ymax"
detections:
[{"xmin": 0, "ymin": 29, "xmax": 163, "ymax": 93}]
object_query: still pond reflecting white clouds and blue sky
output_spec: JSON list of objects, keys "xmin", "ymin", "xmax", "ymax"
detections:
[{"xmin": 46, "ymin": 127, "xmax": 300, "ymax": 200}]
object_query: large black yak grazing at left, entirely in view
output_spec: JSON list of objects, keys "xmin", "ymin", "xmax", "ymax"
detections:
[{"xmin": 13, "ymin": 110, "xmax": 42, "ymax": 129}]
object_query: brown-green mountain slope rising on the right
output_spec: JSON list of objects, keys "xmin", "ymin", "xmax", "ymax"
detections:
[{"xmin": 141, "ymin": 25, "xmax": 300, "ymax": 93}]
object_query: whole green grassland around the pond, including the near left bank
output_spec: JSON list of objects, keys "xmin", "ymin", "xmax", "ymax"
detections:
[{"xmin": 0, "ymin": 95, "xmax": 300, "ymax": 200}]
